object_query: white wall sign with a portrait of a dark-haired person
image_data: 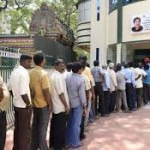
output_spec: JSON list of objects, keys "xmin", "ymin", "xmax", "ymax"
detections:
[{"xmin": 131, "ymin": 14, "xmax": 150, "ymax": 34}]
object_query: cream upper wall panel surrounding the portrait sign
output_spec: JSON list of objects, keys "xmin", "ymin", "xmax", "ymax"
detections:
[{"xmin": 123, "ymin": 0, "xmax": 150, "ymax": 42}]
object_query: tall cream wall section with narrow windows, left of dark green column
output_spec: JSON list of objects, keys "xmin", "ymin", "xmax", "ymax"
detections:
[{"xmin": 90, "ymin": 0, "xmax": 108, "ymax": 66}]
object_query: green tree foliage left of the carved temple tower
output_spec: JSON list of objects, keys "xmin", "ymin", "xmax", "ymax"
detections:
[{"xmin": 1, "ymin": 0, "xmax": 42, "ymax": 34}]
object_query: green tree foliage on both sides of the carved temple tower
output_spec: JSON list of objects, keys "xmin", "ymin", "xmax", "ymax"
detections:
[{"xmin": 0, "ymin": 0, "xmax": 77, "ymax": 34}]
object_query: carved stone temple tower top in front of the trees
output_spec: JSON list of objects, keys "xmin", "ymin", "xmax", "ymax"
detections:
[{"xmin": 30, "ymin": 3, "xmax": 75, "ymax": 46}]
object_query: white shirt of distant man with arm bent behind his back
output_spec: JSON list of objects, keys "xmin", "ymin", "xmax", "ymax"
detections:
[{"xmin": 134, "ymin": 68, "xmax": 147, "ymax": 88}]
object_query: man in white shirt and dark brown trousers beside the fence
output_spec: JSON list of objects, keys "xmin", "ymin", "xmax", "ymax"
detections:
[{"xmin": 10, "ymin": 55, "xmax": 32, "ymax": 150}]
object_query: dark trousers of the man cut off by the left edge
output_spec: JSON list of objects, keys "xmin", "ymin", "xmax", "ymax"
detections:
[{"xmin": 0, "ymin": 111, "xmax": 7, "ymax": 150}]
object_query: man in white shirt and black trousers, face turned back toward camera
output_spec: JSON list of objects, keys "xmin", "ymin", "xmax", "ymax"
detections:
[{"xmin": 50, "ymin": 59, "xmax": 69, "ymax": 150}]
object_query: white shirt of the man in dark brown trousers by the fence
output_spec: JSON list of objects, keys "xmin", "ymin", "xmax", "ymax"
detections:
[{"xmin": 9, "ymin": 65, "xmax": 31, "ymax": 108}]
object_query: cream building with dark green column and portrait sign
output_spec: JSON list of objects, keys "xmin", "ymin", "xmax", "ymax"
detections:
[{"xmin": 77, "ymin": 0, "xmax": 150, "ymax": 65}]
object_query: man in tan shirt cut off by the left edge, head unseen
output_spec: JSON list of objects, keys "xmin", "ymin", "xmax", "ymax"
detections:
[{"xmin": 0, "ymin": 76, "xmax": 10, "ymax": 150}]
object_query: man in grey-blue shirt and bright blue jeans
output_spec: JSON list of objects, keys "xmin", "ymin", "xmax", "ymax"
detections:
[{"xmin": 66, "ymin": 62, "xmax": 87, "ymax": 148}]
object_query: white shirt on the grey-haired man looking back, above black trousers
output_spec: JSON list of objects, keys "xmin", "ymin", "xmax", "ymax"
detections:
[{"xmin": 51, "ymin": 70, "xmax": 69, "ymax": 114}]
